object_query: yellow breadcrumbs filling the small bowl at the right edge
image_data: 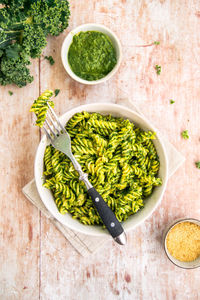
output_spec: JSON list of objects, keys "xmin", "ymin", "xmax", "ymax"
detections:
[{"xmin": 166, "ymin": 222, "xmax": 200, "ymax": 262}]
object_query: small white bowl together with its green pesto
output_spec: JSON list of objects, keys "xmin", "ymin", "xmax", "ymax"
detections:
[{"xmin": 61, "ymin": 24, "xmax": 122, "ymax": 85}]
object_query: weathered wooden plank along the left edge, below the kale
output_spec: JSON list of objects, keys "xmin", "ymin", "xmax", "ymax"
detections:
[{"xmin": 0, "ymin": 61, "xmax": 40, "ymax": 300}]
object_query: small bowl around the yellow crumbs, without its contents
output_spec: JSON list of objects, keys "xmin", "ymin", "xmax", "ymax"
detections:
[{"xmin": 163, "ymin": 218, "xmax": 200, "ymax": 269}]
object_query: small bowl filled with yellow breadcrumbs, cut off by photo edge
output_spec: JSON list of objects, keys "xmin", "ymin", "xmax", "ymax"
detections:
[{"xmin": 164, "ymin": 218, "xmax": 200, "ymax": 269}]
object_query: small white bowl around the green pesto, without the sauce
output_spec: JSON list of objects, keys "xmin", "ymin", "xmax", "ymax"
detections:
[{"xmin": 61, "ymin": 23, "xmax": 122, "ymax": 85}]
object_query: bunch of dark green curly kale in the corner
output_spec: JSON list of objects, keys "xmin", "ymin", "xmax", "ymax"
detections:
[{"xmin": 0, "ymin": 0, "xmax": 70, "ymax": 87}]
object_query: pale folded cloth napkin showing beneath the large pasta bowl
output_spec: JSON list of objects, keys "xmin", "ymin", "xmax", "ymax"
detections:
[{"xmin": 22, "ymin": 99, "xmax": 185, "ymax": 256}]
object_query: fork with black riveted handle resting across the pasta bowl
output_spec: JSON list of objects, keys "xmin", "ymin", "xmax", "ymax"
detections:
[{"xmin": 43, "ymin": 102, "xmax": 126, "ymax": 245}]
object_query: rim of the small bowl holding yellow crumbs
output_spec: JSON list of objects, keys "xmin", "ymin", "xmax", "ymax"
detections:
[{"xmin": 163, "ymin": 218, "xmax": 200, "ymax": 270}]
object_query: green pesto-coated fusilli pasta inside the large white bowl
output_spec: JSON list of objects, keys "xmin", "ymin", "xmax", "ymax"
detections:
[{"xmin": 44, "ymin": 111, "xmax": 162, "ymax": 225}]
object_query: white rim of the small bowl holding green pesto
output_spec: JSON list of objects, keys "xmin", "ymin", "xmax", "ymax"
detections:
[{"xmin": 61, "ymin": 23, "xmax": 122, "ymax": 85}]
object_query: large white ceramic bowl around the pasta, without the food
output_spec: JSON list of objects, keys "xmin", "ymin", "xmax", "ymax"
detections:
[{"xmin": 35, "ymin": 103, "xmax": 168, "ymax": 236}]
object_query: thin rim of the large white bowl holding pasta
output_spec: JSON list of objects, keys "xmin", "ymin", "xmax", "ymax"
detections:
[{"xmin": 34, "ymin": 103, "xmax": 168, "ymax": 236}]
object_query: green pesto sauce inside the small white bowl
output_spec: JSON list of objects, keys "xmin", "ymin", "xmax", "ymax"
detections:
[{"xmin": 68, "ymin": 31, "xmax": 117, "ymax": 81}]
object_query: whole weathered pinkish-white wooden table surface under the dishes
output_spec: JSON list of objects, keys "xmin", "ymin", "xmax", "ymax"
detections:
[{"xmin": 0, "ymin": 0, "xmax": 200, "ymax": 300}]
